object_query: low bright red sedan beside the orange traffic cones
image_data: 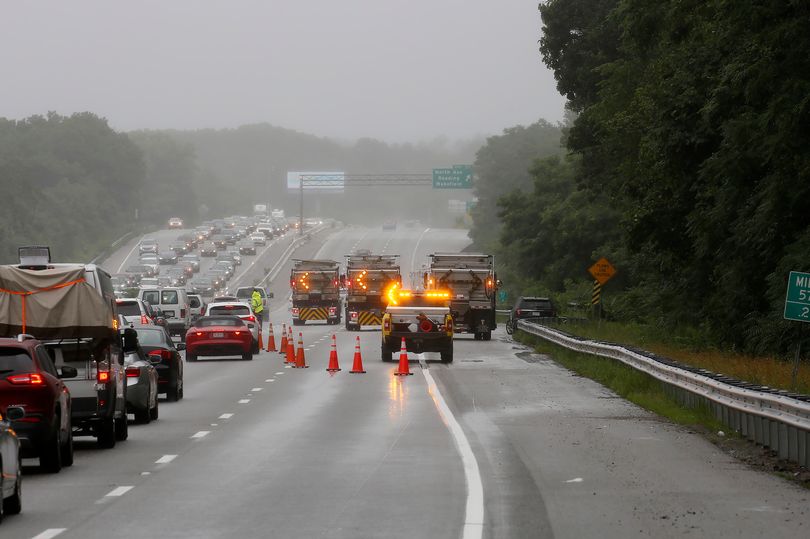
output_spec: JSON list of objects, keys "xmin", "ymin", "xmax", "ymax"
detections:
[{"xmin": 186, "ymin": 315, "xmax": 253, "ymax": 361}]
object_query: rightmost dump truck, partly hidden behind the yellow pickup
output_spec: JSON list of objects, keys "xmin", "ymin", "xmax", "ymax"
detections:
[{"xmin": 424, "ymin": 253, "xmax": 500, "ymax": 341}]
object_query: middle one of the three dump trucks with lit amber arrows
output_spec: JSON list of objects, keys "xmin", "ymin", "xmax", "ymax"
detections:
[{"xmin": 342, "ymin": 252, "xmax": 402, "ymax": 331}]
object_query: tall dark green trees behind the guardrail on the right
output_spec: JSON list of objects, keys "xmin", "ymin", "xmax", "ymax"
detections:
[{"xmin": 477, "ymin": 0, "xmax": 810, "ymax": 352}]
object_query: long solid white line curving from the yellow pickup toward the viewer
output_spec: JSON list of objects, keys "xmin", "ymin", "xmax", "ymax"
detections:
[{"xmin": 422, "ymin": 369, "xmax": 484, "ymax": 539}]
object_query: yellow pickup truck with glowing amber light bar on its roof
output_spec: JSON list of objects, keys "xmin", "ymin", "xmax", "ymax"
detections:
[{"xmin": 381, "ymin": 290, "xmax": 453, "ymax": 363}]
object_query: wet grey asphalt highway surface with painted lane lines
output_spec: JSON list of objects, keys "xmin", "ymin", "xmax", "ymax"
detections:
[{"xmin": 0, "ymin": 227, "xmax": 810, "ymax": 539}]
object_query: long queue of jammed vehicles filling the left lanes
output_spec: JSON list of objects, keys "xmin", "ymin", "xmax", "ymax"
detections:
[{"xmin": 0, "ymin": 217, "xmax": 289, "ymax": 521}]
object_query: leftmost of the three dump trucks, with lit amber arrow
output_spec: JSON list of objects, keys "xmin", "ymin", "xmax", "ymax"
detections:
[{"xmin": 290, "ymin": 260, "xmax": 341, "ymax": 326}]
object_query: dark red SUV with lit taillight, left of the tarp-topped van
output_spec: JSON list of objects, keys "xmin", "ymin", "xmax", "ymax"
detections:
[{"xmin": 0, "ymin": 335, "xmax": 76, "ymax": 472}]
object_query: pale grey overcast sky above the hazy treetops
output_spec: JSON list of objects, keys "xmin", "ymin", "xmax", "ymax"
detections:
[{"xmin": 0, "ymin": 0, "xmax": 564, "ymax": 142}]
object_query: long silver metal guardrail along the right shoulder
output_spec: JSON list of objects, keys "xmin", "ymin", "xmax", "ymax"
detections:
[{"xmin": 518, "ymin": 320, "xmax": 810, "ymax": 466}]
